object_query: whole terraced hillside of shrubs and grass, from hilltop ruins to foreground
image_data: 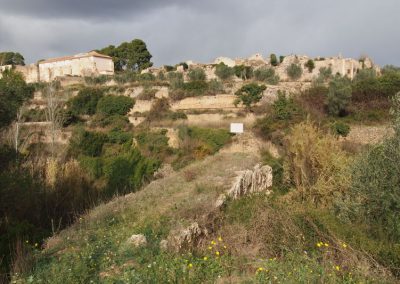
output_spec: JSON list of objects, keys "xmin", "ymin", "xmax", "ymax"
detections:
[{"xmin": 0, "ymin": 51, "xmax": 400, "ymax": 283}]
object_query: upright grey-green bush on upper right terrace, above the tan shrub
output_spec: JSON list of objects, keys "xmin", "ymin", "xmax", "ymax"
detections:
[{"xmin": 326, "ymin": 76, "xmax": 351, "ymax": 116}]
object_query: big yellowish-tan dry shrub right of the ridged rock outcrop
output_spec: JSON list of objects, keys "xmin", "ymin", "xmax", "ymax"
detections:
[{"xmin": 285, "ymin": 121, "xmax": 350, "ymax": 205}]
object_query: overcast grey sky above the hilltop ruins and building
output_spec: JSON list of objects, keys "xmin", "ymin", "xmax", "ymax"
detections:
[{"xmin": 0, "ymin": 0, "xmax": 400, "ymax": 66}]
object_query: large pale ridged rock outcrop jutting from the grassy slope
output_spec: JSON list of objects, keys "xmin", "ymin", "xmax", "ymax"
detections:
[{"xmin": 215, "ymin": 164, "xmax": 272, "ymax": 207}]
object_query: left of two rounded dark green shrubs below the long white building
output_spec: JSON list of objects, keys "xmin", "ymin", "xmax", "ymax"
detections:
[{"xmin": 68, "ymin": 88, "xmax": 103, "ymax": 115}]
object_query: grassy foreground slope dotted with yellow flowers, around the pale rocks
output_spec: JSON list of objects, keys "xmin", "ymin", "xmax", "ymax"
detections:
[{"xmin": 15, "ymin": 145, "xmax": 392, "ymax": 283}]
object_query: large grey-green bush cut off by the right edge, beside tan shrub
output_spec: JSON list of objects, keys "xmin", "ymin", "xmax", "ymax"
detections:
[{"xmin": 342, "ymin": 94, "xmax": 400, "ymax": 240}]
